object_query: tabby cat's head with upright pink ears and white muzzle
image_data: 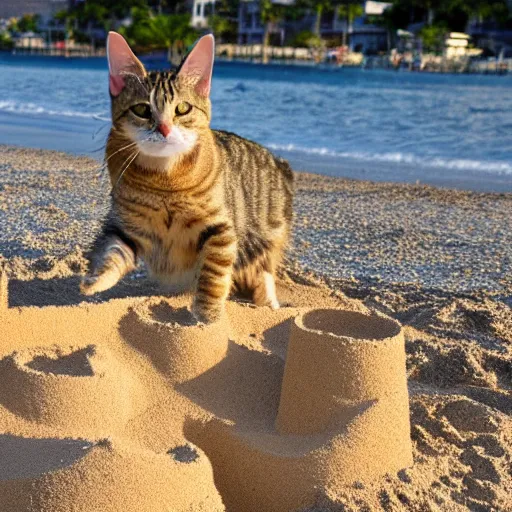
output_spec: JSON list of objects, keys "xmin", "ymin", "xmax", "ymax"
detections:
[{"xmin": 107, "ymin": 32, "xmax": 214, "ymax": 158}]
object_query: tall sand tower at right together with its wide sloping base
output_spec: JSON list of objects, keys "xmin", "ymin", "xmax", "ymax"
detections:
[{"xmin": 190, "ymin": 310, "xmax": 412, "ymax": 512}]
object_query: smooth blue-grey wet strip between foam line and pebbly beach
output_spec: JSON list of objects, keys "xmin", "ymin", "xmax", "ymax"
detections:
[{"xmin": 0, "ymin": 112, "xmax": 512, "ymax": 193}]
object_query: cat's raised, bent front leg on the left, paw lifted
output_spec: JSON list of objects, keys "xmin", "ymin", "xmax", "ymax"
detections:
[{"xmin": 80, "ymin": 224, "xmax": 137, "ymax": 295}]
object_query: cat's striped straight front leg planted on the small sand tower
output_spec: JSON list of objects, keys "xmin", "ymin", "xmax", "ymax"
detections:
[{"xmin": 192, "ymin": 222, "xmax": 237, "ymax": 323}]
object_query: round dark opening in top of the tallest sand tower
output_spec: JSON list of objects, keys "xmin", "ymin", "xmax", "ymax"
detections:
[{"xmin": 303, "ymin": 309, "xmax": 400, "ymax": 340}]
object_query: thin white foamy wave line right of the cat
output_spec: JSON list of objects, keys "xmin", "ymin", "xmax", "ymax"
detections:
[{"xmin": 267, "ymin": 144, "xmax": 512, "ymax": 174}]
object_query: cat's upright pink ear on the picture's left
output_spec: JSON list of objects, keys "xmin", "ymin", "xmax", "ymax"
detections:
[{"xmin": 107, "ymin": 32, "xmax": 146, "ymax": 96}]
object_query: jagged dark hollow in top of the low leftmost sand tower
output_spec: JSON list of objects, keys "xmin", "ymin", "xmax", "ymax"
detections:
[{"xmin": 26, "ymin": 345, "xmax": 95, "ymax": 377}]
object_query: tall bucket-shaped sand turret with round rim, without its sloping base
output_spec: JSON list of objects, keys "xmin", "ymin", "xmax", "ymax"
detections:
[{"xmin": 276, "ymin": 309, "xmax": 409, "ymax": 436}]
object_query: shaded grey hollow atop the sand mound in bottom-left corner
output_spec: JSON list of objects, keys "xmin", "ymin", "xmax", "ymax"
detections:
[{"xmin": 0, "ymin": 434, "xmax": 93, "ymax": 480}]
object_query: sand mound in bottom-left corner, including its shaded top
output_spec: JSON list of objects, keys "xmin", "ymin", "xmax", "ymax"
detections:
[{"xmin": 0, "ymin": 438, "xmax": 224, "ymax": 512}]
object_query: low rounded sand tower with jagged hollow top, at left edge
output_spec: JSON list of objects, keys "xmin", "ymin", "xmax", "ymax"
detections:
[{"xmin": 0, "ymin": 345, "xmax": 141, "ymax": 435}]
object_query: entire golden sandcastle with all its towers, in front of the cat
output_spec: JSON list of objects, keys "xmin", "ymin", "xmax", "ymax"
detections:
[{"xmin": 0, "ymin": 277, "xmax": 412, "ymax": 512}]
